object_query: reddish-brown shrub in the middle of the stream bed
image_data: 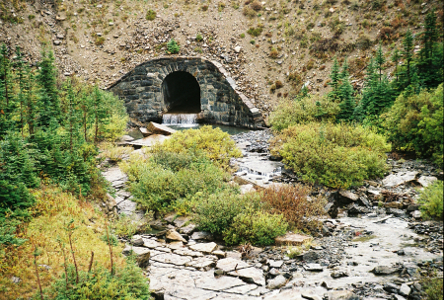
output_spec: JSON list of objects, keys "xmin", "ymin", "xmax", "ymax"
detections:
[{"xmin": 261, "ymin": 184, "xmax": 325, "ymax": 231}]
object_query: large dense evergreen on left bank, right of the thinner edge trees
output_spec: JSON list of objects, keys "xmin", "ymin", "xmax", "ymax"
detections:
[{"xmin": 36, "ymin": 51, "xmax": 61, "ymax": 127}]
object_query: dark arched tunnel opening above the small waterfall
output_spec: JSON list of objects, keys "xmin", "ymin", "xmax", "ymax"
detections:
[{"xmin": 162, "ymin": 71, "xmax": 201, "ymax": 113}]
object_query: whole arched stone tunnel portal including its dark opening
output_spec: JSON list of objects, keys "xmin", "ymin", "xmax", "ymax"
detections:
[{"xmin": 108, "ymin": 57, "xmax": 263, "ymax": 128}]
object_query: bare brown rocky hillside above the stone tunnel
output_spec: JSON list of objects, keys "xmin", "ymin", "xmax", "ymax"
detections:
[{"xmin": 0, "ymin": 0, "xmax": 443, "ymax": 116}]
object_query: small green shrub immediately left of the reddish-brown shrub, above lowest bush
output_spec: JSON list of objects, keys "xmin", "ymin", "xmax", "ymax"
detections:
[{"xmin": 194, "ymin": 192, "xmax": 261, "ymax": 235}]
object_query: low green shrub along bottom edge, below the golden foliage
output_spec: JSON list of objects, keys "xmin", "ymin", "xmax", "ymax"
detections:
[{"xmin": 41, "ymin": 259, "xmax": 151, "ymax": 300}]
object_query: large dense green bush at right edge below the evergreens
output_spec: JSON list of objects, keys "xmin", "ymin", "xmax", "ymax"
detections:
[{"xmin": 383, "ymin": 84, "xmax": 444, "ymax": 168}]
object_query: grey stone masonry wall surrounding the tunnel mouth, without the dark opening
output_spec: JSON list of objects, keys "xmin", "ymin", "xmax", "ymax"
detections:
[{"xmin": 108, "ymin": 57, "xmax": 263, "ymax": 129}]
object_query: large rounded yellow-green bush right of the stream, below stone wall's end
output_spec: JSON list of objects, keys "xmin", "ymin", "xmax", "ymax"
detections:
[{"xmin": 271, "ymin": 123, "xmax": 390, "ymax": 188}]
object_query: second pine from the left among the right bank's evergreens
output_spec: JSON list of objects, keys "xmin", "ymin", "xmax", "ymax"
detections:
[{"xmin": 338, "ymin": 59, "xmax": 355, "ymax": 121}]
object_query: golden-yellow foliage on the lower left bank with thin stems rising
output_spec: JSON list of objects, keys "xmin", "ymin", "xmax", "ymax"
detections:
[{"xmin": 0, "ymin": 186, "xmax": 125, "ymax": 299}]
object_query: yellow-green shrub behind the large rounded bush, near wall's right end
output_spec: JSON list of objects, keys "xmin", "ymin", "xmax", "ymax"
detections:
[{"xmin": 270, "ymin": 95, "xmax": 340, "ymax": 131}]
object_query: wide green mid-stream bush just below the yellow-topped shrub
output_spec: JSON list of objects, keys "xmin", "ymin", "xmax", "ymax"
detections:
[{"xmin": 122, "ymin": 148, "xmax": 232, "ymax": 213}]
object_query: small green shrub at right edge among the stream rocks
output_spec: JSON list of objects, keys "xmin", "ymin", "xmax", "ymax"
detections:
[{"xmin": 418, "ymin": 181, "xmax": 444, "ymax": 220}]
